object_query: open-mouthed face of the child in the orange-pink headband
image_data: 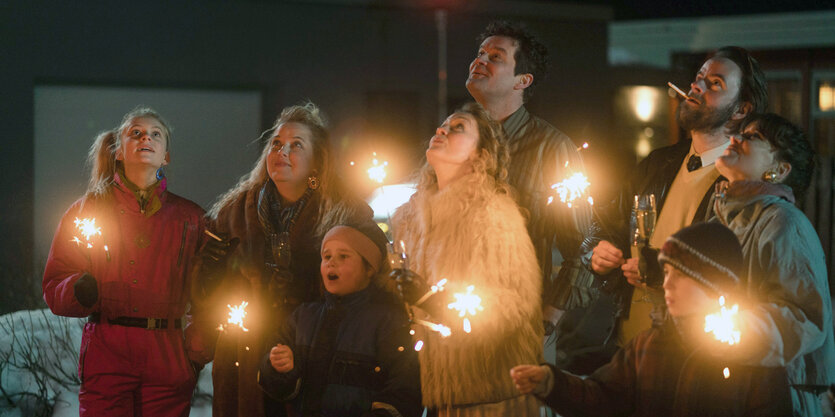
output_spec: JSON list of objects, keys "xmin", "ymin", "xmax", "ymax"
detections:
[{"xmin": 319, "ymin": 239, "xmax": 372, "ymax": 296}]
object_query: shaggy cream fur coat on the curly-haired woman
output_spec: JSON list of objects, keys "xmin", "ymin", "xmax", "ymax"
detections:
[{"xmin": 393, "ymin": 174, "xmax": 543, "ymax": 409}]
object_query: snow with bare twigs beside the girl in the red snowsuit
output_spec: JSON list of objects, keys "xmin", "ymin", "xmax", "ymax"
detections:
[{"xmin": 0, "ymin": 309, "xmax": 212, "ymax": 417}]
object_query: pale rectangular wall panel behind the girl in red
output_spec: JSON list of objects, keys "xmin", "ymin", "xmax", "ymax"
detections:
[{"xmin": 33, "ymin": 85, "xmax": 261, "ymax": 271}]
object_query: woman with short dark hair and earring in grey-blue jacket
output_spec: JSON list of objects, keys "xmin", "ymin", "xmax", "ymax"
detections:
[{"xmin": 714, "ymin": 114, "xmax": 835, "ymax": 416}]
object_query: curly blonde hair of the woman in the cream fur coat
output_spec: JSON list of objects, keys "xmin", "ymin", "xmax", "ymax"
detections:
[{"xmin": 417, "ymin": 102, "xmax": 510, "ymax": 196}]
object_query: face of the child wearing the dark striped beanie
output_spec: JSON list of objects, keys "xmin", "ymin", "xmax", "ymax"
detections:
[{"xmin": 664, "ymin": 264, "xmax": 719, "ymax": 317}]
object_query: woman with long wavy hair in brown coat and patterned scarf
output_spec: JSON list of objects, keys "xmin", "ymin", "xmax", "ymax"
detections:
[{"xmin": 196, "ymin": 103, "xmax": 372, "ymax": 416}]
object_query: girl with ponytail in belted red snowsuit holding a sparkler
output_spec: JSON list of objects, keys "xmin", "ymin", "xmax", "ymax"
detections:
[{"xmin": 43, "ymin": 108, "xmax": 205, "ymax": 417}]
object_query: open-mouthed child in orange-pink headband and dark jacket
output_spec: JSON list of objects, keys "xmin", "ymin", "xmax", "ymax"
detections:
[{"xmin": 258, "ymin": 222, "xmax": 422, "ymax": 417}]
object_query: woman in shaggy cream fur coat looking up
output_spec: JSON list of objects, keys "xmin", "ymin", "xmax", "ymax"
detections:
[{"xmin": 393, "ymin": 103, "xmax": 543, "ymax": 416}]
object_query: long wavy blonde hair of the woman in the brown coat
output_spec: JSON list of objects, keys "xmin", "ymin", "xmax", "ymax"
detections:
[{"xmin": 209, "ymin": 102, "xmax": 352, "ymax": 231}]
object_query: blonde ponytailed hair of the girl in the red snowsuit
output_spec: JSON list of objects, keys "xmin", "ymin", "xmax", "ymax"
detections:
[{"xmin": 85, "ymin": 106, "xmax": 171, "ymax": 198}]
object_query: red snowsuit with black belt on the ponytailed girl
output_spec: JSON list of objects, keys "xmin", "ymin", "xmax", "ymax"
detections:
[{"xmin": 43, "ymin": 174, "xmax": 211, "ymax": 416}]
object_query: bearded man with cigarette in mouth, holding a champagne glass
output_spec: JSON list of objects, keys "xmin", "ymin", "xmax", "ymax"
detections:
[{"xmin": 591, "ymin": 46, "xmax": 768, "ymax": 346}]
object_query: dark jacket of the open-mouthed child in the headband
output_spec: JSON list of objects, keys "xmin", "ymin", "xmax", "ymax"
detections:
[{"xmin": 258, "ymin": 285, "xmax": 422, "ymax": 417}]
